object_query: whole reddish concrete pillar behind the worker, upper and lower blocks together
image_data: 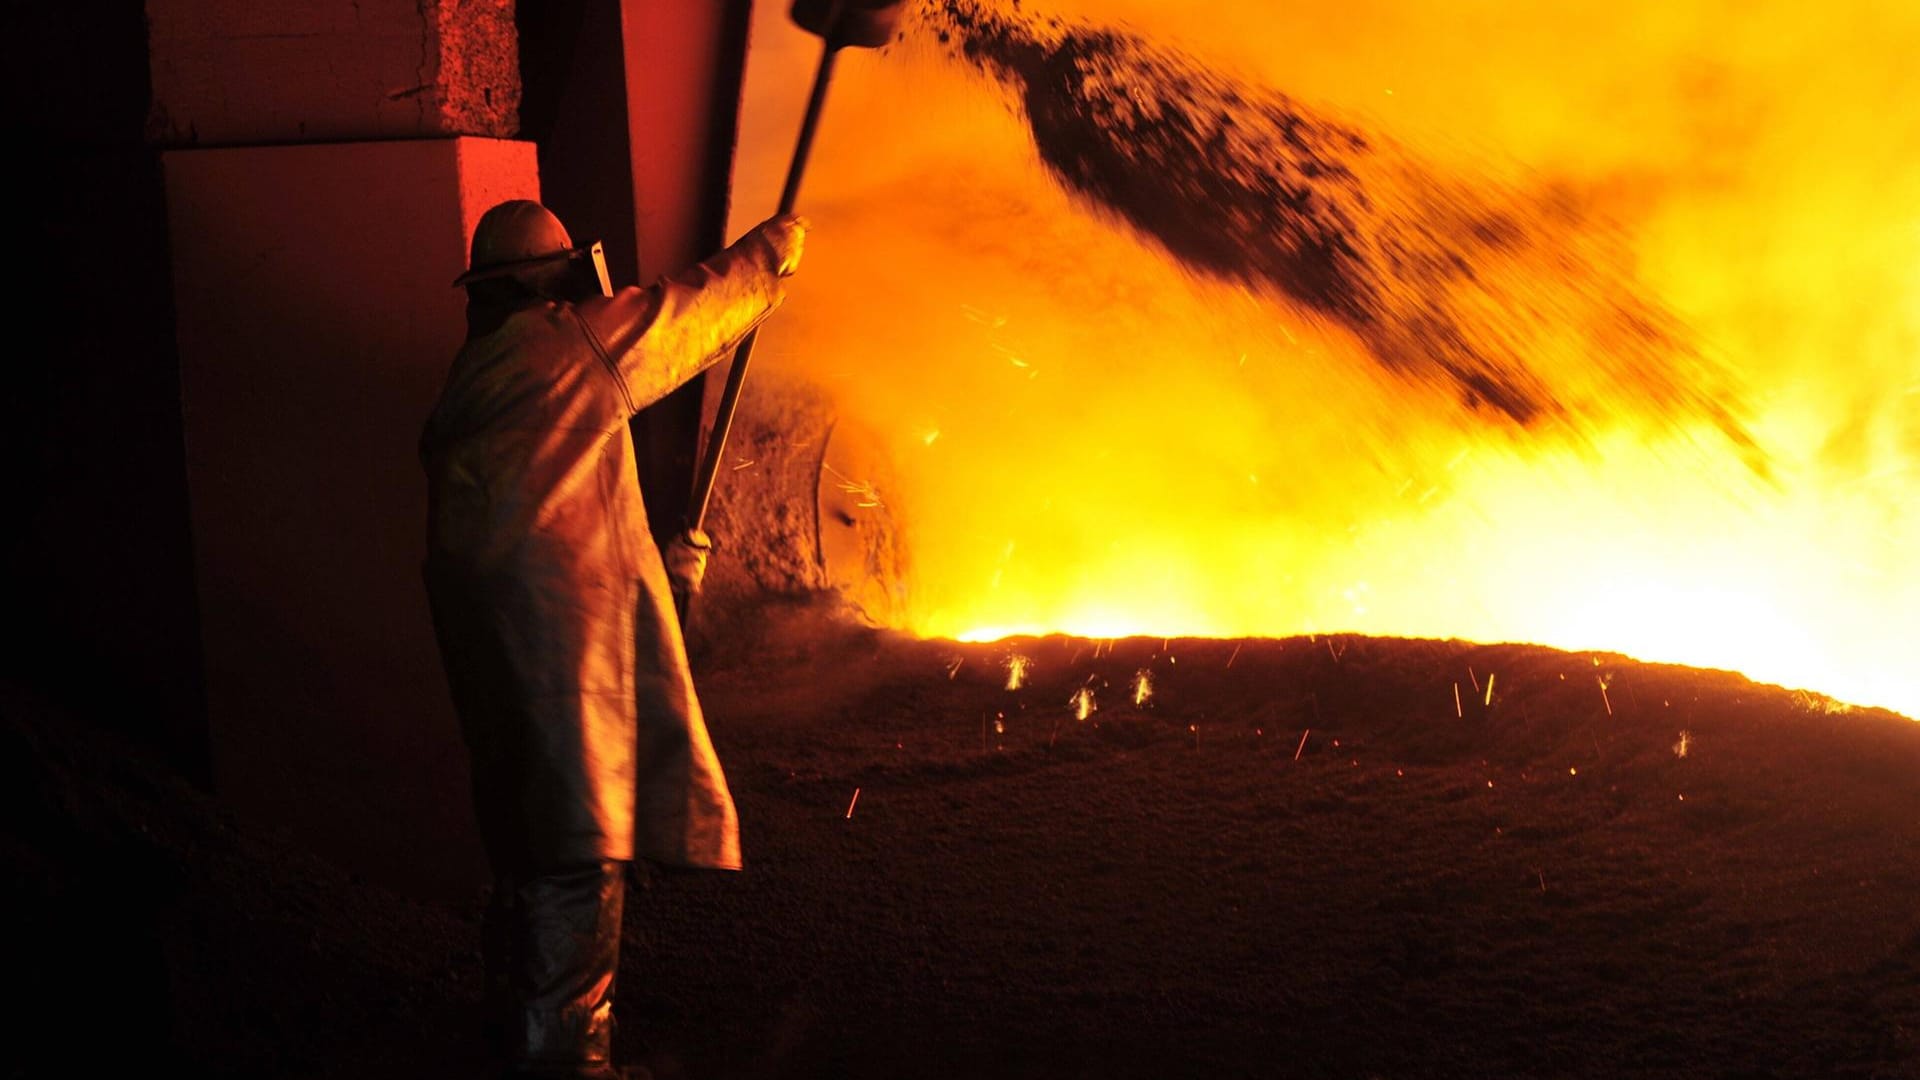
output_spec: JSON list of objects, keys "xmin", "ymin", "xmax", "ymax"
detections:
[{"xmin": 146, "ymin": 0, "xmax": 540, "ymax": 896}]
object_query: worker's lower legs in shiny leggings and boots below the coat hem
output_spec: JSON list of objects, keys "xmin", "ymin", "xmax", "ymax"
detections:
[{"xmin": 490, "ymin": 861, "xmax": 625, "ymax": 1080}]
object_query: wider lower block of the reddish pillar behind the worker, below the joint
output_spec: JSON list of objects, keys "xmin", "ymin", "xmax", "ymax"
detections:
[{"xmin": 161, "ymin": 138, "xmax": 540, "ymax": 896}]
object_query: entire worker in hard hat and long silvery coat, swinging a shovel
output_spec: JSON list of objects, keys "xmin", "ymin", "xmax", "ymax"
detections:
[{"xmin": 420, "ymin": 200, "xmax": 806, "ymax": 1076}]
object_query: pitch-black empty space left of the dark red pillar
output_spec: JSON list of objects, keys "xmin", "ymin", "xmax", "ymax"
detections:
[{"xmin": 0, "ymin": 0, "xmax": 209, "ymax": 784}]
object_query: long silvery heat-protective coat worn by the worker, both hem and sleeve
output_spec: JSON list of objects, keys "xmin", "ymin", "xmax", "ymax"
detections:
[{"xmin": 420, "ymin": 231, "xmax": 781, "ymax": 872}]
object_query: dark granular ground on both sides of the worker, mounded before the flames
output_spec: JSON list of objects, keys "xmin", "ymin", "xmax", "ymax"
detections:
[{"xmin": 0, "ymin": 607, "xmax": 1920, "ymax": 1080}]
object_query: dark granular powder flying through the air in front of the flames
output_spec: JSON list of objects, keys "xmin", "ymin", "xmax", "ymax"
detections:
[{"xmin": 918, "ymin": 0, "xmax": 1759, "ymax": 461}]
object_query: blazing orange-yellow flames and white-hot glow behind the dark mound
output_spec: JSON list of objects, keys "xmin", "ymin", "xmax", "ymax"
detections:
[{"xmin": 733, "ymin": 0, "xmax": 1920, "ymax": 717}]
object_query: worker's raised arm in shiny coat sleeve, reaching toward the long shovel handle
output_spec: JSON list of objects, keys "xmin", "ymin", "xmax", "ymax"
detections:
[{"xmin": 580, "ymin": 213, "xmax": 806, "ymax": 413}]
